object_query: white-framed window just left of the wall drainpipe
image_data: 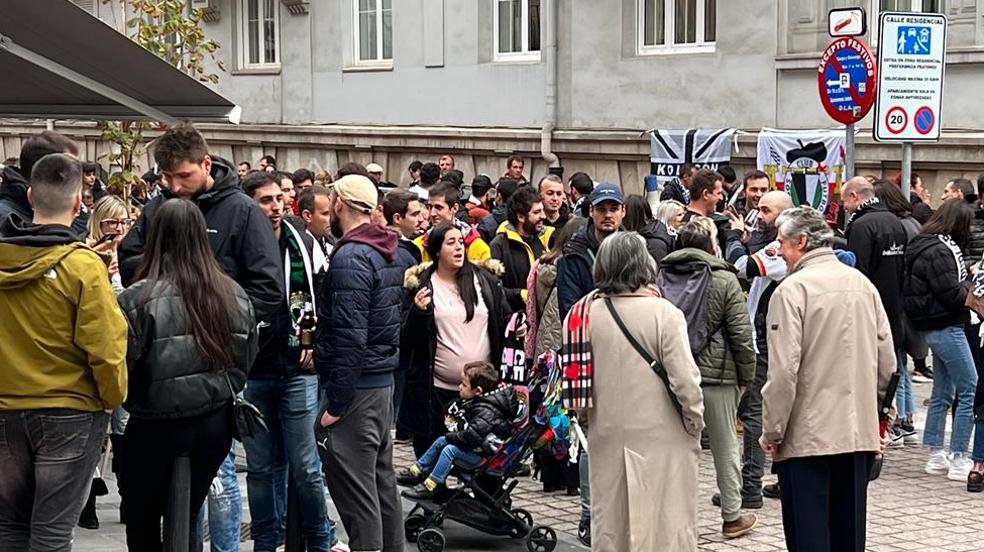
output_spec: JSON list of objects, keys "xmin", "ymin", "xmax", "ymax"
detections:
[{"xmin": 492, "ymin": 0, "xmax": 542, "ymax": 61}]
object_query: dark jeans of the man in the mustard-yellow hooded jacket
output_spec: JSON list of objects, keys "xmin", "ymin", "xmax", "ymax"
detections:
[{"xmin": 0, "ymin": 408, "xmax": 109, "ymax": 552}]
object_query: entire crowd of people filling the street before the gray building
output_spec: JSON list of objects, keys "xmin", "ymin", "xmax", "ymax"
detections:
[{"xmin": 0, "ymin": 125, "xmax": 984, "ymax": 552}]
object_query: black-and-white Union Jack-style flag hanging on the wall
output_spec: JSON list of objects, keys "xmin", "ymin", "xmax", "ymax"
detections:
[{"xmin": 646, "ymin": 128, "xmax": 735, "ymax": 204}]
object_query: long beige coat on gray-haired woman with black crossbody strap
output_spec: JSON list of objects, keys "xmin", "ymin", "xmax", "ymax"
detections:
[{"xmin": 588, "ymin": 293, "xmax": 704, "ymax": 552}]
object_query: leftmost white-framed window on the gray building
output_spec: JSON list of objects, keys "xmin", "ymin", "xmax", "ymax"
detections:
[{"xmin": 239, "ymin": 0, "xmax": 280, "ymax": 69}]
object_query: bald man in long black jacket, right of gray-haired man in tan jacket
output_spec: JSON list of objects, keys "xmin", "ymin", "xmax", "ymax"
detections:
[{"xmin": 841, "ymin": 176, "xmax": 918, "ymax": 446}]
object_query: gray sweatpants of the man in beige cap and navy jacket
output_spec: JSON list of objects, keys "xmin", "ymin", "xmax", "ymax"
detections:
[{"xmin": 318, "ymin": 386, "xmax": 404, "ymax": 552}]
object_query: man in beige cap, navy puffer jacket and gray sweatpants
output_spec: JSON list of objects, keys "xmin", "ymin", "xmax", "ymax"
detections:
[{"xmin": 314, "ymin": 174, "xmax": 404, "ymax": 550}]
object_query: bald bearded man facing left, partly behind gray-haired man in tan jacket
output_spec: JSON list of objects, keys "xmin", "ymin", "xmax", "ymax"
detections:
[{"xmin": 715, "ymin": 191, "xmax": 793, "ymax": 508}]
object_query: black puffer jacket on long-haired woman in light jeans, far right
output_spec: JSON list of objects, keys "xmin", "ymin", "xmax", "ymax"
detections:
[{"xmin": 902, "ymin": 234, "xmax": 970, "ymax": 331}]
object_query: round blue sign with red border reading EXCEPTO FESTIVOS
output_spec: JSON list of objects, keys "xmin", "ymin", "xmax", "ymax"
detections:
[{"xmin": 817, "ymin": 37, "xmax": 878, "ymax": 125}]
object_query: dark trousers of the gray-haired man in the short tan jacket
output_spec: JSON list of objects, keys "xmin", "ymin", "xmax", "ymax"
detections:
[{"xmin": 773, "ymin": 452, "xmax": 875, "ymax": 552}]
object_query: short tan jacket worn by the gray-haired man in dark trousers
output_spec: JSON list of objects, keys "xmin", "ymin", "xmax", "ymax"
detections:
[{"xmin": 762, "ymin": 248, "xmax": 897, "ymax": 461}]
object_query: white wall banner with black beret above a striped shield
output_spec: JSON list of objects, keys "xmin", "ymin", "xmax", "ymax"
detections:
[{"xmin": 758, "ymin": 128, "xmax": 846, "ymax": 213}]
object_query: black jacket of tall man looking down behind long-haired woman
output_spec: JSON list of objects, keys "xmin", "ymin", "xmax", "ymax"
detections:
[{"xmin": 118, "ymin": 156, "xmax": 284, "ymax": 322}]
